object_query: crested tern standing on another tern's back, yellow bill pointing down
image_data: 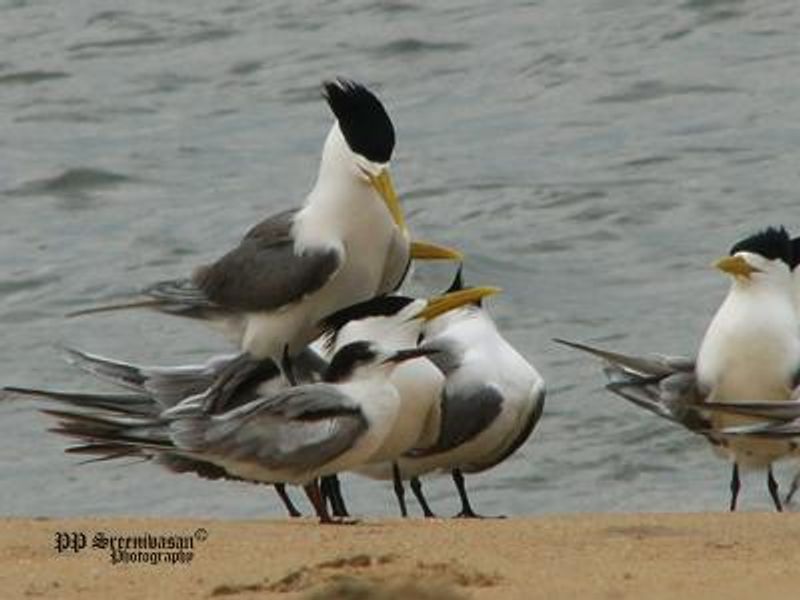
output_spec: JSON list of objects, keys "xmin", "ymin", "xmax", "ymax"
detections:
[{"xmin": 72, "ymin": 79, "xmax": 461, "ymax": 361}]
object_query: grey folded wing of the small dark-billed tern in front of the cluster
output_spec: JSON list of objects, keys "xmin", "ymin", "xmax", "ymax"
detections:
[{"xmin": 171, "ymin": 384, "xmax": 367, "ymax": 471}]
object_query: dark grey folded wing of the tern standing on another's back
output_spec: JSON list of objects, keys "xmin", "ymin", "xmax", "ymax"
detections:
[{"xmin": 192, "ymin": 211, "xmax": 344, "ymax": 311}]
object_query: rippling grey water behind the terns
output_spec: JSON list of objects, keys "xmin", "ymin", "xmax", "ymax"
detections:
[{"xmin": 0, "ymin": 0, "xmax": 800, "ymax": 516}]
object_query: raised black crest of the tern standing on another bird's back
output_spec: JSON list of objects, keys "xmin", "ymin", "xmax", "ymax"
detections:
[{"xmin": 323, "ymin": 77, "xmax": 395, "ymax": 163}]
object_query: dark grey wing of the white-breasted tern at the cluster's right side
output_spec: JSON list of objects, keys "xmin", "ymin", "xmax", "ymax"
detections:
[{"xmin": 409, "ymin": 386, "xmax": 503, "ymax": 457}]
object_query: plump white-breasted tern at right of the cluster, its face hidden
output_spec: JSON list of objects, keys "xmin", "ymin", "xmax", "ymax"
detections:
[{"xmin": 359, "ymin": 269, "xmax": 545, "ymax": 518}]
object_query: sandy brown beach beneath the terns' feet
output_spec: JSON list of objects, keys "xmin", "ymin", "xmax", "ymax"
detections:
[{"xmin": 0, "ymin": 513, "xmax": 800, "ymax": 600}]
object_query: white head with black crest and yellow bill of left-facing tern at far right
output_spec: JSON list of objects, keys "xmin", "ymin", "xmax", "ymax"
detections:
[{"xmin": 714, "ymin": 227, "xmax": 800, "ymax": 290}]
